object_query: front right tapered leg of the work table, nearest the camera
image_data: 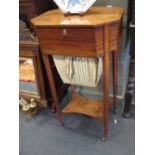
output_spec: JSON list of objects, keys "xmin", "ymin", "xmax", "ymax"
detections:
[{"xmin": 103, "ymin": 25, "xmax": 110, "ymax": 139}]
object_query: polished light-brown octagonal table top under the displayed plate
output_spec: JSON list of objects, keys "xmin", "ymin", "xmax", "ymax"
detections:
[{"xmin": 31, "ymin": 6, "xmax": 124, "ymax": 27}]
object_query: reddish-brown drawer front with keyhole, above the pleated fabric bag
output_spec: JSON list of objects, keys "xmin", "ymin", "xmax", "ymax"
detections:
[{"xmin": 37, "ymin": 27, "xmax": 103, "ymax": 56}]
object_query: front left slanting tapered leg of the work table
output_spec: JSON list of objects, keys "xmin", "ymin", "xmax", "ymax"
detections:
[{"xmin": 43, "ymin": 55, "xmax": 63, "ymax": 125}]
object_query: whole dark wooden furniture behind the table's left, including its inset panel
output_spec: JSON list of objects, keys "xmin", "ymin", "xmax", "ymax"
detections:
[{"xmin": 19, "ymin": 0, "xmax": 67, "ymax": 114}]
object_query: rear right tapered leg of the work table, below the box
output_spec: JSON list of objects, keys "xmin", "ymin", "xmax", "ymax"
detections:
[{"xmin": 112, "ymin": 50, "xmax": 118, "ymax": 112}]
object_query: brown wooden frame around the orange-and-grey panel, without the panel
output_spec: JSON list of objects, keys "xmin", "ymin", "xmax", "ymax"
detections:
[{"xmin": 19, "ymin": 41, "xmax": 47, "ymax": 107}]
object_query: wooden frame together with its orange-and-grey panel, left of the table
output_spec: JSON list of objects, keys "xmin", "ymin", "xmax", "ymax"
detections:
[{"xmin": 19, "ymin": 41, "xmax": 47, "ymax": 108}]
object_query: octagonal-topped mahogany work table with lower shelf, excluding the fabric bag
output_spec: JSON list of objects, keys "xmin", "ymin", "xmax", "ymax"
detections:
[{"xmin": 31, "ymin": 6, "xmax": 124, "ymax": 139}]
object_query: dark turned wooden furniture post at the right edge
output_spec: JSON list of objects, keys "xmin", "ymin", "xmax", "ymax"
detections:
[{"xmin": 123, "ymin": 0, "xmax": 135, "ymax": 118}]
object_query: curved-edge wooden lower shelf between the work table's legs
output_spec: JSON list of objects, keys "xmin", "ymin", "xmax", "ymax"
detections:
[{"xmin": 62, "ymin": 94, "xmax": 111, "ymax": 119}]
